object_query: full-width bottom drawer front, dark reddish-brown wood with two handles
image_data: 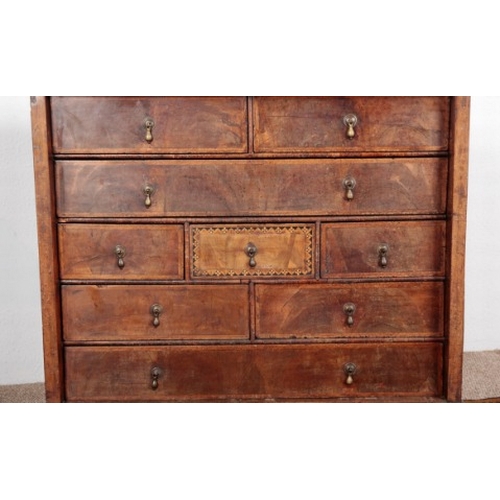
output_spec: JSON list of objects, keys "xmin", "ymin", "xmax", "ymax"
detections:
[{"xmin": 65, "ymin": 343, "xmax": 442, "ymax": 401}]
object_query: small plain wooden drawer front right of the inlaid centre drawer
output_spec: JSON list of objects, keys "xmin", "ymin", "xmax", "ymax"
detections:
[{"xmin": 321, "ymin": 221, "xmax": 446, "ymax": 278}]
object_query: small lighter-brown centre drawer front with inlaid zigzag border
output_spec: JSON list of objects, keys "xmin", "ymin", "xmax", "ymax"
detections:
[{"xmin": 191, "ymin": 224, "xmax": 314, "ymax": 278}]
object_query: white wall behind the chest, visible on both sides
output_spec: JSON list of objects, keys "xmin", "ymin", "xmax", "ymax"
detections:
[{"xmin": 0, "ymin": 97, "xmax": 500, "ymax": 384}]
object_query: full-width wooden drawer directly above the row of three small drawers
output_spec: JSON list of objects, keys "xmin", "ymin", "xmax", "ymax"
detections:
[{"xmin": 56, "ymin": 158, "xmax": 448, "ymax": 217}]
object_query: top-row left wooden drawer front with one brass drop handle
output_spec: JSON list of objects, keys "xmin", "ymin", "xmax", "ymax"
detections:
[{"xmin": 51, "ymin": 97, "xmax": 247, "ymax": 154}]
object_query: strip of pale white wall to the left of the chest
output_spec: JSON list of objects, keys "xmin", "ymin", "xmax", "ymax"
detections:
[{"xmin": 0, "ymin": 97, "xmax": 44, "ymax": 384}]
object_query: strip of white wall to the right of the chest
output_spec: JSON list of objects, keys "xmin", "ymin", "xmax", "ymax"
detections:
[{"xmin": 465, "ymin": 96, "xmax": 500, "ymax": 351}]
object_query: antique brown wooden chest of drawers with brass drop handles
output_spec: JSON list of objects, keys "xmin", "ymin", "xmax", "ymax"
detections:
[{"xmin": 32, "ymin": 97, "xmax": 469, "ymax": 402}]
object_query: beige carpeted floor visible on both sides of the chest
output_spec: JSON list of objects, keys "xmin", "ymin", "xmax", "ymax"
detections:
[{"xmin": 0, "ymin": 350, "xmax": 500, "ymax": 403}]
